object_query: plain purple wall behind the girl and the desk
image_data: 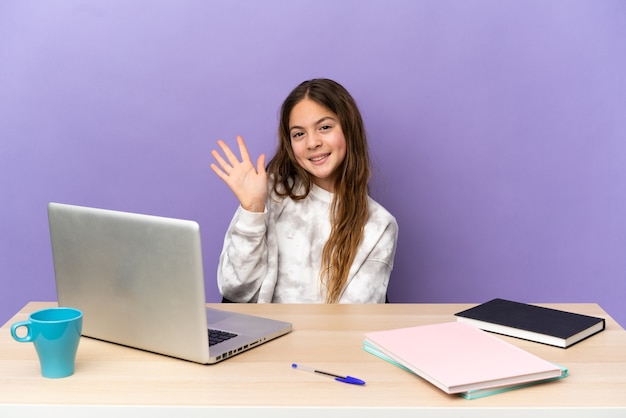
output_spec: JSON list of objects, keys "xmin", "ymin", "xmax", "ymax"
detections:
[{"xmin": 0, "ymin": 0, "xmax": 626, "ymax": 325}]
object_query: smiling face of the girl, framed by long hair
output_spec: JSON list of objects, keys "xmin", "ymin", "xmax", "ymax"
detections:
[{"xmin": 289, "ymin": 99, "xmax": 346, "ymax": 192}]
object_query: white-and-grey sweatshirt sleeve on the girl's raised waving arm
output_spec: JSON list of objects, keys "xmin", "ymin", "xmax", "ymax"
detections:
[{"xmin": 217, "ymin": 206, "xmax": 268, "ymax": 302}]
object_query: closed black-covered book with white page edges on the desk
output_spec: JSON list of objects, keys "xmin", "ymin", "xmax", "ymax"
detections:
[{"xmin": 455, "ymin": 299, "xmax": 605, "ymax": 348}]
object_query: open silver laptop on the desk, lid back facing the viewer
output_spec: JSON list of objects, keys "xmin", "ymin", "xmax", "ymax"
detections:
[{"xmin": 48, "ymin": 203, "xmax": 292, "ymax": 364}]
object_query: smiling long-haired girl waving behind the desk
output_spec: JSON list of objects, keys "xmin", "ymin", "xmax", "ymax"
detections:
[{"xmin": 211, "ymin": 79, "xmax": 398, "ymax": 303}]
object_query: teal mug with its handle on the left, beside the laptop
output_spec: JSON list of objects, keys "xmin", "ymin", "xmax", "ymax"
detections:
[{"xmin": 11, "ymin": 308, "xmax": 83, "ymax": 378}]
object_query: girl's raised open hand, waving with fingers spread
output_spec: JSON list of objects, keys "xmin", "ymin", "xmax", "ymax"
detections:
[{"xmin": 211, "ymin": 136, "xmax": 267, "ymax": 212}]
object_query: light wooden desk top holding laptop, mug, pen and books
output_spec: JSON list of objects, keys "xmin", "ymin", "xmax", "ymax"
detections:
[{"xmin": 0, "ymin": 302, "xmax": 626, "ymax": 418}]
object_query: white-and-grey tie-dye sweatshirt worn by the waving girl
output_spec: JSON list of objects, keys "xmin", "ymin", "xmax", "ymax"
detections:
[{"xmin": 217, "ymin": 181, "xmax": 398, "ymax": 303}]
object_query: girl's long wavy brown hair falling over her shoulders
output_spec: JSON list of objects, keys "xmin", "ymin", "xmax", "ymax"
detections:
[{"xmin": 267, "ymin": 79, "xmax": 370, "ymax": 303}]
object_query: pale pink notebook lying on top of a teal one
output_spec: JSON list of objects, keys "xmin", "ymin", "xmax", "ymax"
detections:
[{"xmin": 364, "ymin": 322, "xmax": 562, "ymax": 393}]
